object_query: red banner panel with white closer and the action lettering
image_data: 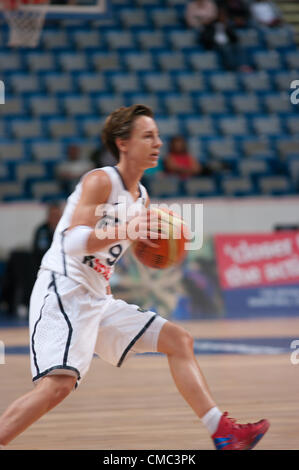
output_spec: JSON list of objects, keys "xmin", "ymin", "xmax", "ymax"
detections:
[{"xmin": 214, "ymin": 232, "xmax": 299, "ymax": 289}]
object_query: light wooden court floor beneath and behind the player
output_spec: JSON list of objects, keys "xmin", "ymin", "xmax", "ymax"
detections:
[{"xmin": 0, "ymin": 318, "xmax": 299, "ymax": 450}]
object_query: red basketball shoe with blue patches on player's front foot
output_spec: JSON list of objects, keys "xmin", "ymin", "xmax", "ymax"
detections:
[{"xmin": 212, "ymin": 412, "xmax": 270, "ymax": 450}]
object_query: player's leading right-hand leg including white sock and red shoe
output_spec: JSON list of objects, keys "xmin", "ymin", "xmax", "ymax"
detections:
[{"xmin": 157, "ymin": 322, "xmax": 269, "ymax": 450}]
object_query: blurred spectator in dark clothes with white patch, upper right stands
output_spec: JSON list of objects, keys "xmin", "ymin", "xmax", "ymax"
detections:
[{"xmin": 200, "ymin": 8, "xmax": 252, "ymax": 72}]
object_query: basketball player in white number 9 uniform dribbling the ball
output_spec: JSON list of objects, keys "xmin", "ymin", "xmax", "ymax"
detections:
[{"xmin": 0, "ymin": 105, "xmax": 269, "ymax": 449}]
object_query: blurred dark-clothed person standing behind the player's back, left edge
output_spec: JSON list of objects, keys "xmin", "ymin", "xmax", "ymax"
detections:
[{"xmin": 1, "ymin": 204, "xmax": 62, "ymax": 318}]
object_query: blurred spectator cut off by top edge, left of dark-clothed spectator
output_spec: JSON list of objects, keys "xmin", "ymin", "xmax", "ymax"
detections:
[{"xmin": 185, "ymin": 0, "xmax": 218, "ymax": 29}]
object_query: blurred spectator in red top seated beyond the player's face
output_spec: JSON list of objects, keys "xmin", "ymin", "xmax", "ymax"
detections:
[{"xmin": 164, "ymin": 136, "xmax": 202, "ymax": 179}]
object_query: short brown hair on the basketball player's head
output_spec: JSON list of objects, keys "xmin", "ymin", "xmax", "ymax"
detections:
[{"xmin": 102, "ymin": 104, "xmax": 154, "ymax": 160}]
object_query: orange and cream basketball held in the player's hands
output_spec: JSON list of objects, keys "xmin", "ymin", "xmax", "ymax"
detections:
[{"xmin": 132, "ymin": 208, "xmax": 187, "ymax": 269}]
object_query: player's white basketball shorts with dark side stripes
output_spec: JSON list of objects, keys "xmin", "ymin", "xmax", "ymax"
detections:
[{"xmin": 29, "ymin": 270, "xmax": 167, "ymax": 385}]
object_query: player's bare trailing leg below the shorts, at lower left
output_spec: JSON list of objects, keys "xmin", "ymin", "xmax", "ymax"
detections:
[{"xmin": 0, "ymin": 375, "xmax": 77, "ymax": 445}]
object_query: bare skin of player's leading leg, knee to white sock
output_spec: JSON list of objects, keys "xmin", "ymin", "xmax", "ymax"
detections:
[{"xmin": 157, "ymin": 322, "xmax": 216, "ymax": 418}]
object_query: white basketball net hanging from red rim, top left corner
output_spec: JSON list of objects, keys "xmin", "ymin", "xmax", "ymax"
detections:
[{"xmin": 0, "ymin": 0, "xmax": 49, "ymax": 47}]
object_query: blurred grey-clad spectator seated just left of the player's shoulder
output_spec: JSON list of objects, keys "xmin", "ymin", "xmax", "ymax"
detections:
[{"xmin": 56, "ymin": 145, "xmax": 93, "ymax": 194}]
